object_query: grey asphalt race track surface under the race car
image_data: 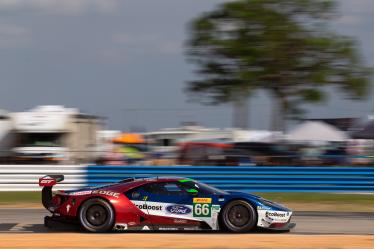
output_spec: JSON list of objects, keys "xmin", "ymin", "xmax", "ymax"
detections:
[{"xmin": 0, "ymin": 208, "xmax": 374, "ymax": 235}]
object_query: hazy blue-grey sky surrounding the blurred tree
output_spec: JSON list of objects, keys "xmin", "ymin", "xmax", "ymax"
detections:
[{"xmin": 0, "ymin": 0, "xmax": 374, "ymax": 130}]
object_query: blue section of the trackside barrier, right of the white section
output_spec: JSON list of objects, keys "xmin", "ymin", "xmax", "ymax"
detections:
[{"xmin": 87, "ymin": 166, "xmax": 374, "ymax": 193}]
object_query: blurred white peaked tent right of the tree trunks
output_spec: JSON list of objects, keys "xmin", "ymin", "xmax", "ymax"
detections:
[{"xmin": 286, "ymin": 121, "xmax": 349, "ymax": 142}]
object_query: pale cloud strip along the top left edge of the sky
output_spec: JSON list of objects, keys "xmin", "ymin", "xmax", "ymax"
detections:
[{"xmin": 0, "ymin": 0, "xmax": 119, "ymax": 15}]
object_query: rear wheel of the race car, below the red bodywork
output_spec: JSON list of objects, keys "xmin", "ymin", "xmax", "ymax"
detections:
[{"xmin": 78, "ymin": 198, "xmax": 115, "ymax": 233}]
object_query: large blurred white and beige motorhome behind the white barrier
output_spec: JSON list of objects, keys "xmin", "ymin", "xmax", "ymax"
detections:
[{"xmin": 11, "ymin": 105, "xmax": 103, "ymax": 163}]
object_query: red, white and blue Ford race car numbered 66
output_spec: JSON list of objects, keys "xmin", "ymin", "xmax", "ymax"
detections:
[{"xmin": 39, "ymin": 175, "xmax": 295, "ymax": 233}]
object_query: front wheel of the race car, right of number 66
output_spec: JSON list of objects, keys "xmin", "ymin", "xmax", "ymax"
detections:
[{"xmin": 221, "ymin": 200, "xmax": 257, "ymax": 233}]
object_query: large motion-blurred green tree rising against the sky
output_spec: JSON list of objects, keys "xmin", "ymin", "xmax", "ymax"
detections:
[{"xmin": 187, "ymin": 0, "xmax": 370, "ymax": 130}]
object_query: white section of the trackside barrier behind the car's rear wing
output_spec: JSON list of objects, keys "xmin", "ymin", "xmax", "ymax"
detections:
[{"xmin": 0, "ymin": 165, "xmax": 87, "ymax": 191}]
